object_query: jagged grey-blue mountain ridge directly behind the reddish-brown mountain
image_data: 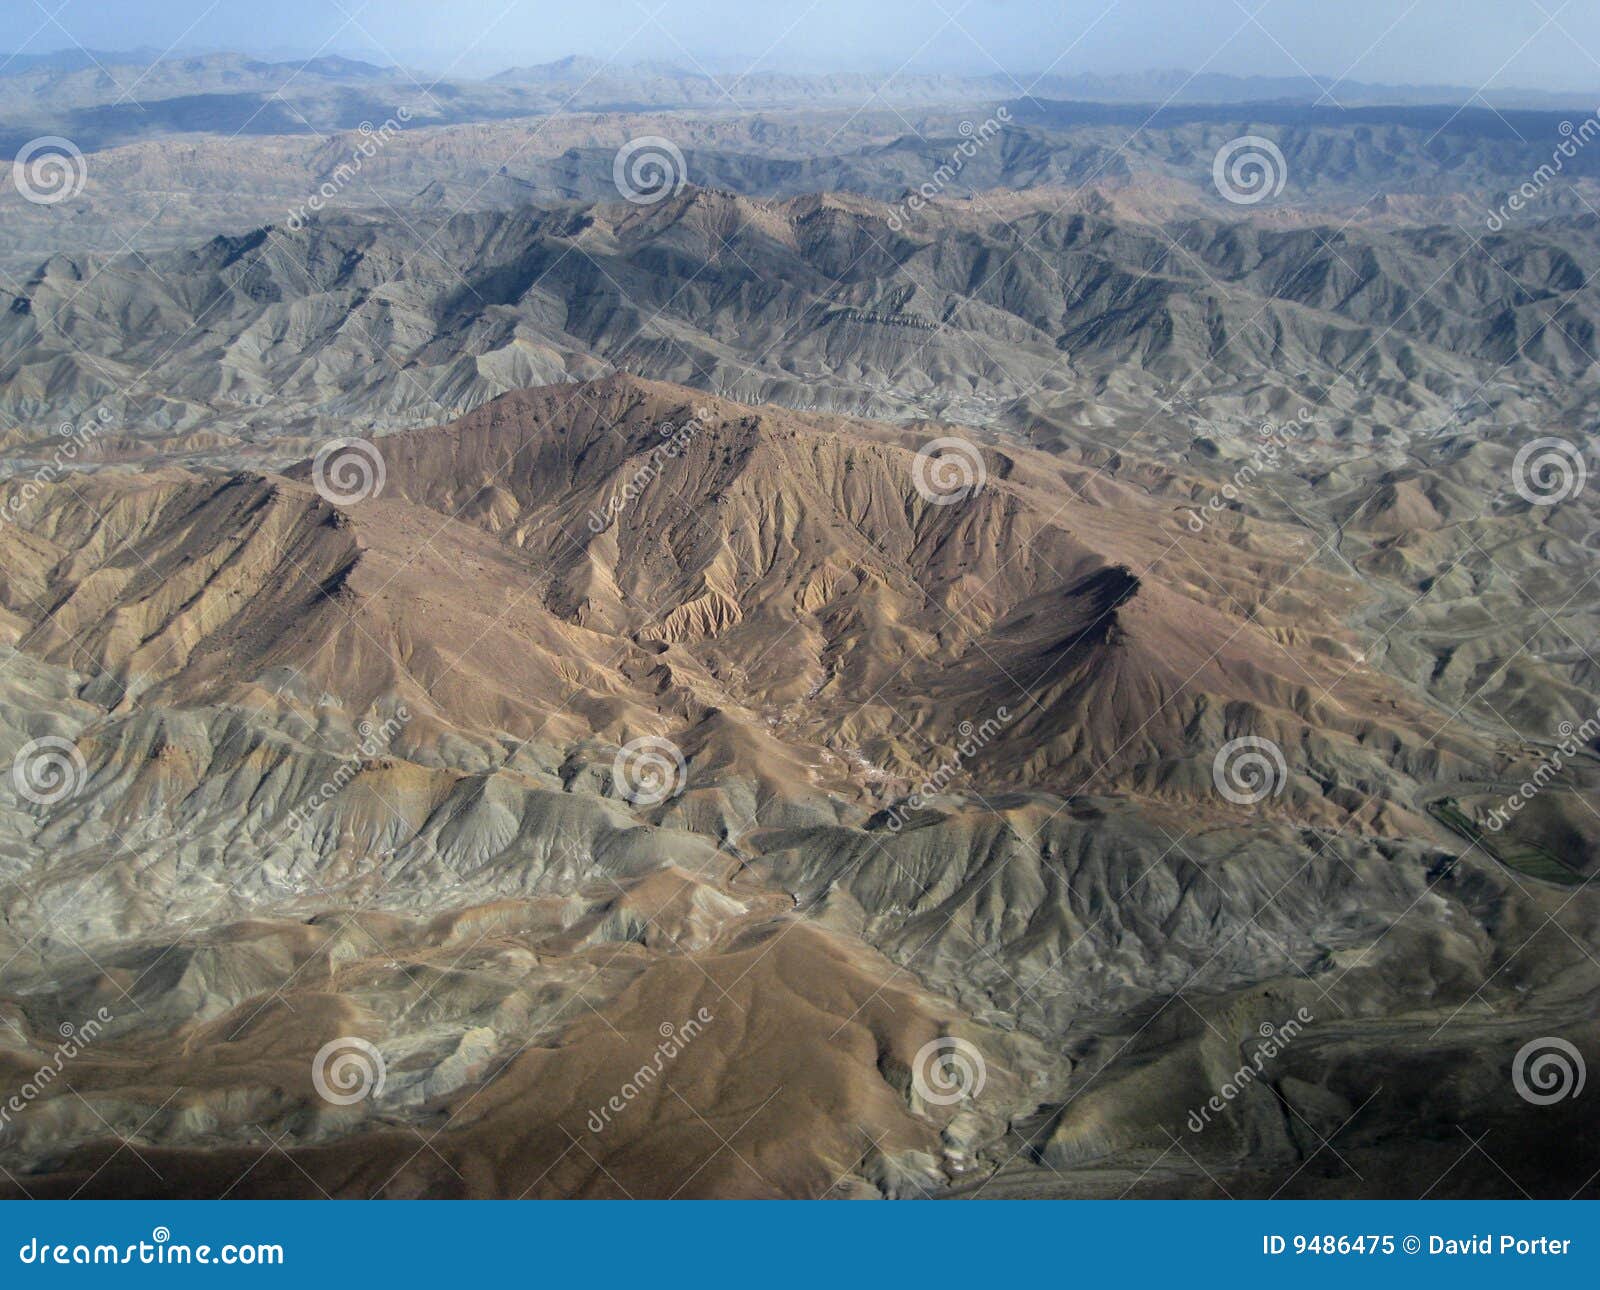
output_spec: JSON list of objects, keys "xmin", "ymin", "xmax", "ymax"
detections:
[{"xmin": 0, "ymin": 189, "xmax": 1600, "ymax": 439}]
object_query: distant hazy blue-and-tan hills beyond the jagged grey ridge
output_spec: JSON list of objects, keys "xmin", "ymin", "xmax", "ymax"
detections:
[{"xmin": 0, "ymin": 92, "xmax": 1600, "ymax": 275}]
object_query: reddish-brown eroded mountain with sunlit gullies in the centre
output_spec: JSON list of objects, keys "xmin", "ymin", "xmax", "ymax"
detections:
[{"xmin": 6, "ymin": 378, "xmax": 1483, "ymax": 808}]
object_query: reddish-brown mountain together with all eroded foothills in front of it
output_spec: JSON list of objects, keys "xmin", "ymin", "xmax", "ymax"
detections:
[{"xmin": 0, "ymin": 376, "xmax": 1600, "ymax": 1196}]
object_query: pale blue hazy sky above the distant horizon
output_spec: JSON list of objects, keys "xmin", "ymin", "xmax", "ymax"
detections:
[{"xmin": 9, "ymin": 0, "xmax": 1600, "ymax": 90}]
